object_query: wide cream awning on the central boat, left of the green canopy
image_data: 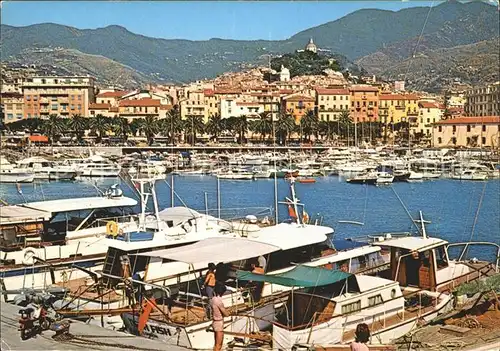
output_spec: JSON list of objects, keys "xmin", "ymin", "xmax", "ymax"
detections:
[{"xmin": 137, "ymin": 238, "xmax": 280, "ymax": 266}]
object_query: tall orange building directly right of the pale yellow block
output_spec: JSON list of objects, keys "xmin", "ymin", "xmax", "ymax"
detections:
[{"xmin": 349, "ymin": 85, "xmax": 379, "ymax": 122}]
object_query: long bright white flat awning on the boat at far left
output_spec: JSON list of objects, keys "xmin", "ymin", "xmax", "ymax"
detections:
[{"xmin": 22, "ymin": 196, "xmax": 137, "ymax": 215}]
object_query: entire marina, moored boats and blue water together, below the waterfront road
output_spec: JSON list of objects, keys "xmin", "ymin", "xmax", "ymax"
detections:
[{"xmin": 0, "ymin": 147, "xmax": 500, "ymax": 350}]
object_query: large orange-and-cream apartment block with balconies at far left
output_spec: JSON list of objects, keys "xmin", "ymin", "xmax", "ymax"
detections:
[{"xmin": 21, "ymin": 77, "xmax": 95, "ymax": 118}]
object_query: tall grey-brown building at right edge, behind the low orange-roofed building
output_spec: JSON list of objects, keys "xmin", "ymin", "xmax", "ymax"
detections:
[{"xmin": 464, "ymin": 82, "xmax": 500, "ymax": 116}]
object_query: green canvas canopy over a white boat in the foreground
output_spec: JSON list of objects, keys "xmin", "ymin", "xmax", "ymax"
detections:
[{"xmin": 236, "ymin": 265, "xmax": 354, "ymax": 288}]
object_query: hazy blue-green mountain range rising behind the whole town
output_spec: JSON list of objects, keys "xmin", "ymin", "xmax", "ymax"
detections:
[{"xmin": 0, "ymin": 1, "xmax": 499, "ymax": 86}]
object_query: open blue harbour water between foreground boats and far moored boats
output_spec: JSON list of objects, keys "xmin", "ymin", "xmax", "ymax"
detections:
[{"xmin": 0, "ymin": 176, "xmax": 500, "ymax": 256}]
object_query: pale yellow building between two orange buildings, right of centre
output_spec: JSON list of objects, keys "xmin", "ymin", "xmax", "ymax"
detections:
[{"xmin": 316, "ymin": 88, "xmax": 350, "ymax": 122}]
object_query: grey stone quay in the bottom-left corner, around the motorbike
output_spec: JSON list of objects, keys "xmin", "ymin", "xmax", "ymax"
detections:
[{"xmin": 0, "ymin": 302, "xmax": 187, "ymax": 351}]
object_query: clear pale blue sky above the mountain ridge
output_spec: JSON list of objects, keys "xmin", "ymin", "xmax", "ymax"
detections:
[{"xmin": 1, "ymin": 0, "xmax": 450, "ymax": 40}]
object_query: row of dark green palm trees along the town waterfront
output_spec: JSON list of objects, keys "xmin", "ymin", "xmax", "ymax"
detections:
[{"xmin": 5, "ymin": 107, "xmax": 402, "ymax": 145}]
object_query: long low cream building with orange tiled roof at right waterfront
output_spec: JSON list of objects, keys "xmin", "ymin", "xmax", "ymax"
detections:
[{"xmin": 432, "ymin": 116, "xmax": 500, "ymax": 148}]
